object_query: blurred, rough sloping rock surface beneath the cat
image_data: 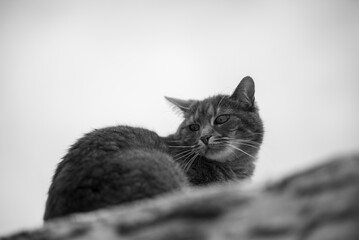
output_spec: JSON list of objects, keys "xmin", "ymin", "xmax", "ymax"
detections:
[{"xmin": 1, "ymin": 155, "xmax": 359, "ymax": 240}]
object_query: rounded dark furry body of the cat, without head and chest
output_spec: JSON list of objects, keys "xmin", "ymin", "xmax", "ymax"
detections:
[{"xmin": 44, "ymin": 126, "xmax": 187, "ymax": 220}]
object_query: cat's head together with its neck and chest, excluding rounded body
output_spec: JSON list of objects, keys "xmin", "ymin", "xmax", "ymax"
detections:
[{"xmin": 164, "ymin": 77, "xmax": 264, "ymax": 185}]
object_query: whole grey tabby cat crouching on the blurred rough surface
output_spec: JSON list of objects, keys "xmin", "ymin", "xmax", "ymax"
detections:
[{"xmin": 44, "ymin": 77, "xmax": 263, "ymax": 221}]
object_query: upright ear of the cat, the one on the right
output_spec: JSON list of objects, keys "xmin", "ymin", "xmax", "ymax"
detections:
[{"xmin": 230, "ymin": 76, "xmax": 255, "ymax": 109}]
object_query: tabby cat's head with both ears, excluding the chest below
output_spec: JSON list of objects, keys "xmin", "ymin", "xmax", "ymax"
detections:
[{"xmin": 166, "ymin": 77, "xmax": 263, "ymax": 162}]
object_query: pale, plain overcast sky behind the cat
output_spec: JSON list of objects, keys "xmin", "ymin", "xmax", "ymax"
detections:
[{"xmin": 0, "ymin": 0, "xmax": 359, "ymax": 235}]
